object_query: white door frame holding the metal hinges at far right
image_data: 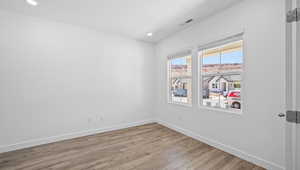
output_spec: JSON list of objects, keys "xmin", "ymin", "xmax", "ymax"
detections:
[{"xmin": 285, "ymin": 0, "xmax": 300, "ymax": 170}]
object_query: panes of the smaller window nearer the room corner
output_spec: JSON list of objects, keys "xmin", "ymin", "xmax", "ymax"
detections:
[{"xmin": 168, "ymin": 54, "xmax": 192, "ymax": 105}]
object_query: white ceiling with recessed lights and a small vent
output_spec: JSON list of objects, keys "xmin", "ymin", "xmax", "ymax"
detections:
[{"xmin": 0, "ymin": 0, "xmax": 241, "ymax": 42}]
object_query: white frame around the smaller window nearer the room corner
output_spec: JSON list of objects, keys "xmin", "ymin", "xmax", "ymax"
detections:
[{"xmin": 166, "ymin": 49, "xmax": 194, "ymax": 107}]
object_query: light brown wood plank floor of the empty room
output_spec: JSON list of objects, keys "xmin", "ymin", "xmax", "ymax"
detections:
[{"xmin": 0, "ymin": 123, "xmax": 263, "ymax": 170}]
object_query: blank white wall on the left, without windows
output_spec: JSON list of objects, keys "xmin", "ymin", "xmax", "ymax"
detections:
[{"xmin": 0, "ymin": 11, "xmax": 154, "ymax": 151}]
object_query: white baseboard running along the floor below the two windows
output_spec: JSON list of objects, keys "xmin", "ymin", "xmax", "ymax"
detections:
[{"xmin": 156, "ymin": 120, "xmax": 285, "ymax": 170}]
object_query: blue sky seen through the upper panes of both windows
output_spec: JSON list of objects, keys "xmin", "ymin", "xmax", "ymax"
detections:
[{"xmin": 171, "ymin": 51, "xmax": 243, "ymax": 65}]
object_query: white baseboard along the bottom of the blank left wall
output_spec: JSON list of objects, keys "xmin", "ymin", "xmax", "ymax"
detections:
[{"xmin": 0, "ymin": 120, "xmax": 155, "ymax": 153}]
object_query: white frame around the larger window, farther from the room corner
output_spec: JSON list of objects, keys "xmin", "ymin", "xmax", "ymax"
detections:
[{"xmin": 196, "ymin": 33, "xmax": 246, "ymax": 114}]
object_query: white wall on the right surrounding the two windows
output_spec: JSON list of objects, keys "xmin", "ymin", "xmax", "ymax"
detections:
[{"xmin": 156, "ymin": 0, "xmax": 285, "ymax": 169}]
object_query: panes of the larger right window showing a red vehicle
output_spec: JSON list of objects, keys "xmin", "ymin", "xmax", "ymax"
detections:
[{"xmin": 198, "ymin": 37, "xmax": 243, "ymax": 110}]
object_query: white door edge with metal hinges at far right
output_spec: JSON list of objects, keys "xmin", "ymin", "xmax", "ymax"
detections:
[{"xmin": 286, "ymin": 0, "xmax": 300, "ymax": 170}]
